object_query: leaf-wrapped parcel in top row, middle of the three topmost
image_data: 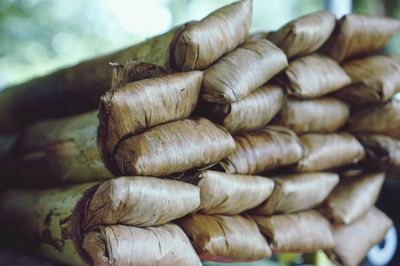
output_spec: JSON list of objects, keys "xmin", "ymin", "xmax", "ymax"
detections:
[{"xmin": 268, "ymin": 11, "xmax": 336, "ymax": 58}]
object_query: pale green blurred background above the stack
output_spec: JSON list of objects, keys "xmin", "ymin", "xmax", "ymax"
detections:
[{"xmin": 0, "ymin": 0, "xmax": 400, "ymax": 90}]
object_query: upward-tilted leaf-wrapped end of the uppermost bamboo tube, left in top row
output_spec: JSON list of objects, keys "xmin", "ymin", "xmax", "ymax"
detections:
[{"xmin": 175, "ymin": 0, "xmax": 252, "ymax": 71}]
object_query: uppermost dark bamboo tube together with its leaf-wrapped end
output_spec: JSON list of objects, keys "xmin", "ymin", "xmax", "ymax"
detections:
[{"xmin": 0, "ymin": 0, "xmax": 252, "ymax": 133}]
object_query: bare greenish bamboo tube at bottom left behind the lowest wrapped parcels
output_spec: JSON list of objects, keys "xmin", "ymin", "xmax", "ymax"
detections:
[{"xmin": 0, "ymin": 183, "xmax": 96, "ymax": 265}]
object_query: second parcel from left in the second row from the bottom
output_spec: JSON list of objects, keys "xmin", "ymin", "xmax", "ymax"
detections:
[{"xmin": 191, "ymin": 170, "xmax": 274, "ymax": 215}]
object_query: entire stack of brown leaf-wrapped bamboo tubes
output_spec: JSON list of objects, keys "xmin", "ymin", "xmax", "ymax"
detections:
[{"xmin": 0, "ymin": 0, "xmax": 400, "ymax": 265}]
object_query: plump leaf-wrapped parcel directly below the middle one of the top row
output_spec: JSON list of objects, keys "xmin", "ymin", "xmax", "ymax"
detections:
[{"xmin": 282, "ymin": 54, "xmax": 351, "ymax": 99}]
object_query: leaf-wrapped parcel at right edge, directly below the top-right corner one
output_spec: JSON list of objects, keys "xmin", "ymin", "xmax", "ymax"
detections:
[{"xmin": 336, "ymin": 55, "xmax": 400, "ymax": 104}]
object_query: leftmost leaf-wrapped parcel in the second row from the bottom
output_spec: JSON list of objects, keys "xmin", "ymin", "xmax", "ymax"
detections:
[{"xmin": 82, "ymin": 176, "xmax": 200, "ymax": 230}]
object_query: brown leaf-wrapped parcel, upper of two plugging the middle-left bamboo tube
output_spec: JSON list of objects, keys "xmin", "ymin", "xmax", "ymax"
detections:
[{"xmin": 98, "ymin": 71, "xmax": 203, "ymax": 165}]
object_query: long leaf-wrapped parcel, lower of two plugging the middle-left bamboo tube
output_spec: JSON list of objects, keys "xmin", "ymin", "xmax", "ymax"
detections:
[{"xmin": 114, "ymin": 118, "xmax": 235, "ymax": 176}]
